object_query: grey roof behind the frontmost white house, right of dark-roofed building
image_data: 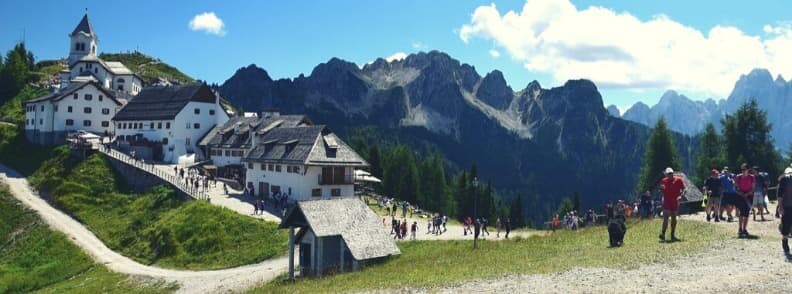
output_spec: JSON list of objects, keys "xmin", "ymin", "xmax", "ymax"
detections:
[{"xmin": 199, "ymin": 115, "xmax": 311, "ymax": 148}]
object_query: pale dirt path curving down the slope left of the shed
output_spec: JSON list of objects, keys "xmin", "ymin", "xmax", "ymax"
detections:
[{"xmin": 0, "ymin": 165, "xmax": 288, "ymax": 293}]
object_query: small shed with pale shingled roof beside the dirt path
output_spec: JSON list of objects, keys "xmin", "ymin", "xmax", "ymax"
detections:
[{"xmin": 280, "ymin": 198, "xmax": 401, "ymax": 278}]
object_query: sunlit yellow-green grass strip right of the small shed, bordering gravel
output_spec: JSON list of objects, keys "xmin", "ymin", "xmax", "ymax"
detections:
[{"xmin": 251, "ymin": 221, "xmax": 727, "ymax": 293}]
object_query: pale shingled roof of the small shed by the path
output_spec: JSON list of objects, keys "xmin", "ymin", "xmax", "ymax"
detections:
[{"xmin": 280, "ymin": 198, "xmax": 401, "ymax": 260}]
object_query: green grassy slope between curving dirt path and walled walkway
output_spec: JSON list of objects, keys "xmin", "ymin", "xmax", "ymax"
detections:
[{"xmin": 30, "ymin": 152, "xmax": 287, "ymax": 270}]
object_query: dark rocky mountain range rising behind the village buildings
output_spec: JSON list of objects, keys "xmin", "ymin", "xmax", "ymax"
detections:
[{"xmin": 218, "ymin": 51, "xmax": 693, "ymax": 220}]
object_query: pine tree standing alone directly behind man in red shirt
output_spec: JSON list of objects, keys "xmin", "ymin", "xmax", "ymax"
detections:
[{"xmin": 637, "ymin": 117, "xmax": 681, "ymax": 191}]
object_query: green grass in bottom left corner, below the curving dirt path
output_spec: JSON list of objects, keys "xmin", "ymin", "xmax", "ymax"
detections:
[{"xmin": 0, "ymin": 185, "xmax": 169, "ymax": 293}]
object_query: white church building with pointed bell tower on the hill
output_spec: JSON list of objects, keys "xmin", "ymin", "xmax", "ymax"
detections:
[{"xmin": 23, "ymin": 14, "xmax": 143, "ymax": 144}]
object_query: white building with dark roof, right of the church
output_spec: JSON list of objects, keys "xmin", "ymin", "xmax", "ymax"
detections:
[{"xmin": 113, "ymin": 83, "xmax": 229, "ymax": 163}]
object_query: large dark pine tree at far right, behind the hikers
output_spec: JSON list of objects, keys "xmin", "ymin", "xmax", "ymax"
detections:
[{"xmin": 721, "ymin": 100, "xmax": 782, "ymax": 175}]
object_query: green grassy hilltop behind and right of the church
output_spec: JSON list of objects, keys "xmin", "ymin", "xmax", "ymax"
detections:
[{"xmin": 99, "ymin": 53, "xmax": 193, "ymax": 85}]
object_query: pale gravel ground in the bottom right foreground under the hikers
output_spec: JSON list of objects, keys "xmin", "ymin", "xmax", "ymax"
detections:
[{"xmin": 399, "ymin": 207, "xmax": 792, "ymax": 293}]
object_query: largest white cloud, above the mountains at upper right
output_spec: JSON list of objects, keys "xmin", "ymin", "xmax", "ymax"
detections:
[{"xmin": 459, "ymin": 0, "xmax": 792, "ymax": 96}]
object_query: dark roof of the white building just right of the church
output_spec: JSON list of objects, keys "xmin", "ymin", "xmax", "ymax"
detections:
[{"xmin": 113, "ymin": 83, "xmax": 214, "ymax": 121}]
